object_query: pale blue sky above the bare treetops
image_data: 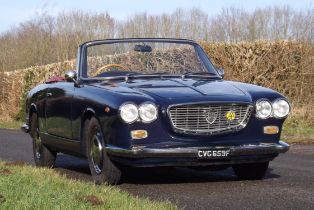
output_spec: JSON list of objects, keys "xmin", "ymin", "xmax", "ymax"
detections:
[{"xmin": 0, "ymin": 0, "xmax": 314, "ymax": 33}]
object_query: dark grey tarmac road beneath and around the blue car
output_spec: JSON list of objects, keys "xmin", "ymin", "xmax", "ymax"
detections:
[{"xmin": 0, "ymin": 130, "xmax": 314, "ymax": 209}]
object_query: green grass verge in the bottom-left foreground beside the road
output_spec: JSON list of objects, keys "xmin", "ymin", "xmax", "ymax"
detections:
[{"xmin": 0, "ymin": 161, "xmax": 177, "ymax": 210}]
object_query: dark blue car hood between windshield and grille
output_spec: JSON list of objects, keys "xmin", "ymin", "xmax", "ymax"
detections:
[{"xmin": 93, "ymin": 78, "xmax": 252, "ymax": 102}]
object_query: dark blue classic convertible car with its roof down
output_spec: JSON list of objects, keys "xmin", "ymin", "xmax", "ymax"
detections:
[{"xmin": 22, "ymin": 39, "xmax": 290, "ymax": 184}]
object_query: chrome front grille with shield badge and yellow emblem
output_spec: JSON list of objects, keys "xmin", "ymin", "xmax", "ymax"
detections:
[{"xmin": 168, "ymin": 104, "xmax": 253, "ymax": 135}]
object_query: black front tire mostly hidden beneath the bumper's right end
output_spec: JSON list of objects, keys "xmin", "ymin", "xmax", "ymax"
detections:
[{"xmin": 232, "ymin": 162, "xmax": 269, "ymax": 180}]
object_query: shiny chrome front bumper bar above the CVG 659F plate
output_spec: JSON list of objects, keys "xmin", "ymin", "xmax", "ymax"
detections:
[{"xmin": 106, "ymin": 141, "xmax": 289, "ymax": 158}]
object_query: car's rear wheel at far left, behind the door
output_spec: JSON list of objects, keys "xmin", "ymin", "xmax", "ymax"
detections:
[{"xmin": 30, "ymin": 113, "xmax": 57, "ymax": 168}]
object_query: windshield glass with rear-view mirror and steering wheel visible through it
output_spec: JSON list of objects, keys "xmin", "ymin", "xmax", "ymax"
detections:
[{"xmin": 85, "ymin": 41, "xmax": 217, "ymax": 78}]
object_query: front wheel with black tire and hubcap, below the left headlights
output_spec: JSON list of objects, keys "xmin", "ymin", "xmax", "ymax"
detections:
[{"xmin": 84, "ymin": 117, "xmax": 121, "ymax": 185}]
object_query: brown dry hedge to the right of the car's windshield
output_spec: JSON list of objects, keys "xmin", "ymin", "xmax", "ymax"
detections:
[{"xmin": 203, "ymin": 41, "xmax": 314, "ymax": 106}]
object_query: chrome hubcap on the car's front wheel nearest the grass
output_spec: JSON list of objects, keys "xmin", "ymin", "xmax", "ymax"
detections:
[{"xmin": 90, "ymin": 131, "xmax": 103, "ymax": 174}]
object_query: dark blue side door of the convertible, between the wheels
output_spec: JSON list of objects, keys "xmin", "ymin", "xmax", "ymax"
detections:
[{"xmin": 45, "ymin": 82, "xmax": 74, "ymax": 139}]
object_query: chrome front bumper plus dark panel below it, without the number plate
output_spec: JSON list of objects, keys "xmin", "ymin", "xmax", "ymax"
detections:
[{"xmin": 106, "ymin": 141, "xmax": 289, "ymax": 166}]
